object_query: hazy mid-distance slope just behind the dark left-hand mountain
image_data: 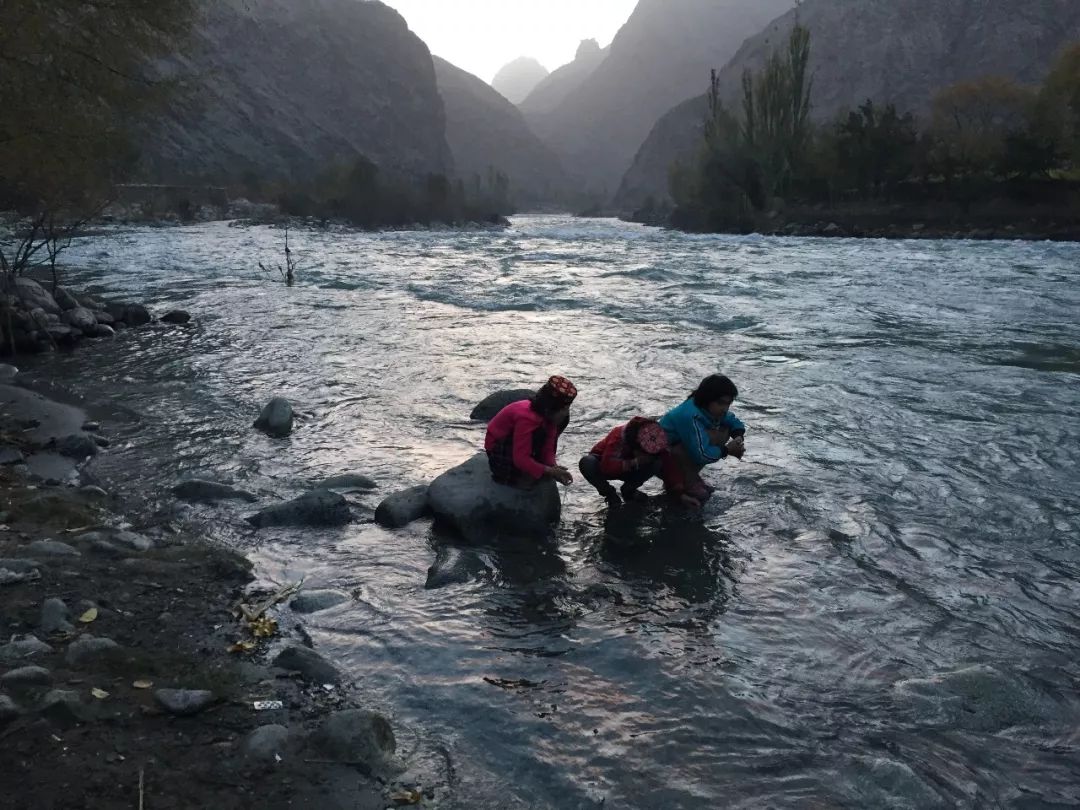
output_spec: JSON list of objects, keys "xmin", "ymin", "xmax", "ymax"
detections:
[{"xmin": 435, "ymin": 56, "xmax": 568, "ymax": 208}]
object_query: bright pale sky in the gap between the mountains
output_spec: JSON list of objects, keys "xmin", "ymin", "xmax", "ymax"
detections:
[{"xmin": 382, "ymin": 0, "xmax": 637, "ymax": 82}]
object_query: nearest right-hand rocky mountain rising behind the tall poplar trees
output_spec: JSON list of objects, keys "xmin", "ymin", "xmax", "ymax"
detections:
[{"xmin": 616, "ymin": 0, "xmax": 1080, "ymax": 211}]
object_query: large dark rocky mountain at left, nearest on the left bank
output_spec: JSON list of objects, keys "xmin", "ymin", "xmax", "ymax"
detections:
[{"xmin": 141, "ymin": 0, "xmax": 453, "ymax": 184}]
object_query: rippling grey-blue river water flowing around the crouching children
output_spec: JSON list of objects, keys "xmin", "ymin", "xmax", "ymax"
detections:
[{"xmin": 16, "ymin": 217, "xmax": 1080, "ymax": 808}]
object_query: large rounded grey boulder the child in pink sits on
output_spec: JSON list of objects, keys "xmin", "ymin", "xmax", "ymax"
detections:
[{"xmin": 428, "ymin": 453, "xmax": 563, "ymax": 542}]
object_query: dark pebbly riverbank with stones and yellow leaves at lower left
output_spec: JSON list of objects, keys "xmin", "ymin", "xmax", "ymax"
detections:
[{"xmin": 0, "ymin": 378, "xmax": 446, "ymax": 810}]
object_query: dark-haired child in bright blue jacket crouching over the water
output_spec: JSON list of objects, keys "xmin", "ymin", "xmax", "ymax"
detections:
[{"xmin": 660, "ymin": 374, "xmax": 746, "ymax": 504}]
